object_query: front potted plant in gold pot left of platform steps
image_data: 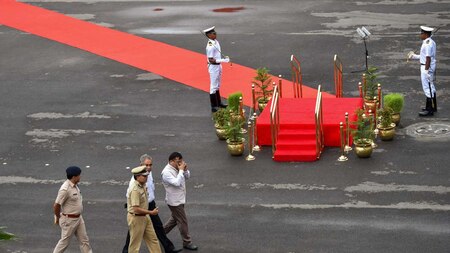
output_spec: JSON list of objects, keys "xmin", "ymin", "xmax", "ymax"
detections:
[{"xmin": 225, "ymin": 111, "xmax": 244, "ymax": 156}]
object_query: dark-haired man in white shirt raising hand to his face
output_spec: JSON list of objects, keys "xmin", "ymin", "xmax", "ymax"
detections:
[{"xmin": 161, "ymin": 152, "xmax": 198, "ymax": 250}]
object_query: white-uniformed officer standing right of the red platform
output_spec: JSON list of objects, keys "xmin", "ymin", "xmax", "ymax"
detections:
[{"xmin": 408, "ymin": 26, "xmax": 437, "ymax": 116}]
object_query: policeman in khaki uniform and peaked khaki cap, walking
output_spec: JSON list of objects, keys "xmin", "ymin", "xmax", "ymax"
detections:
[{"xmin": 127, "ymin": 166, "xmax": 161, "ymax": 253}]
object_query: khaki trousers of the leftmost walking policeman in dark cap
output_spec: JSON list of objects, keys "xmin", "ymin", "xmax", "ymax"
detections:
[{"xmin": 53, "ymin": 215, "xmax": 92, "ymax": 253}]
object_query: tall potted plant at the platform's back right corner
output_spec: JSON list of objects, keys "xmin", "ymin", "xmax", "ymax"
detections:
[{"xmin": 363, "ymin": 67, "xmax": 379, "ymax": 112}]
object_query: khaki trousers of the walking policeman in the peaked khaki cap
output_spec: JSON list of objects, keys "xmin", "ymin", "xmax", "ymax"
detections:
[{"xmin": 127, "ymin": 213, "xmax": 161, "ymax": 253}]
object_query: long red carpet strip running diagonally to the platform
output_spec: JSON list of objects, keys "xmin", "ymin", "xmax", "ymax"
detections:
[{"xmin": 0, "ymin": 0, "xmax": 330, "ymax": 105}]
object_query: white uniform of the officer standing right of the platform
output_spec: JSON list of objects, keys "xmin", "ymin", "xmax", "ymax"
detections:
[{"xmin": 412, "ymin": 37, "xmax": 436, "ymax": 98}]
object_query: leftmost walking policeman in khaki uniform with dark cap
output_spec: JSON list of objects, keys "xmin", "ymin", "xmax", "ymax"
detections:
[{"xmin": 53, "ymin": 166, "xmax": 92, "ymax": 253}]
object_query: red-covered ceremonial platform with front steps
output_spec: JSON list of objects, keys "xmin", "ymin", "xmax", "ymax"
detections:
[{"xmin": 256, "ymin": 97, "xmax": 363, "ymax": 162}]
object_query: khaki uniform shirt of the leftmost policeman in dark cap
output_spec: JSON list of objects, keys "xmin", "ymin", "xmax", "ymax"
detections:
[{"xmin": 55, "ymin": 180, "xmax": 83, "ymax": 214}]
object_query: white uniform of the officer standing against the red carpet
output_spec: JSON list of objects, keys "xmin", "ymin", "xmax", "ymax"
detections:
[{"xmin": 206, "ymin": 39, "xmax": 222, "ymax": 94}]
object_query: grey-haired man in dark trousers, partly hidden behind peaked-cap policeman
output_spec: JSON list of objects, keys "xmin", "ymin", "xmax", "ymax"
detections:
[{"xmin": 122, "ymin": 154, "xmax": 182, "ymax": 253}]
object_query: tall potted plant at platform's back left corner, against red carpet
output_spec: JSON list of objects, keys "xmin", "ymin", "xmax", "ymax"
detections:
[{"xmin": 252, "ymin": 67, "xmax": 273, "ymax": 111}]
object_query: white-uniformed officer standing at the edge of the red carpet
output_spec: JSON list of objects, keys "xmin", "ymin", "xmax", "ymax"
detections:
[{"xmin": 203, "ymin": 26, "xmax": 230, "ymax": 112}]
